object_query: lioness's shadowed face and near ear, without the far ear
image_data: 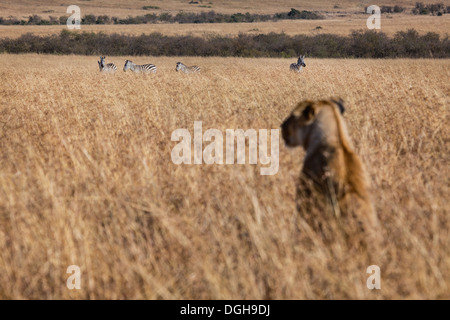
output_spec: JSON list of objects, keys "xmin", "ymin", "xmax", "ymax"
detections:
[{"xmin": 281, "ymin": 101, "xmax": 315, "ymax": 147}]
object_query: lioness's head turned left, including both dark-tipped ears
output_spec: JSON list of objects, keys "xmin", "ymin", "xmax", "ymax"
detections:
[{"xmin": 281, "ymin": 100, "xmax": 345, "ymax": 147}]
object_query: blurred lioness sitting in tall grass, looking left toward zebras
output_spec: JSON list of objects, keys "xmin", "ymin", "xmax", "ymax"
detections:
[{"xmin": 281, "ymin": 100, "xmax": 376, "ymax": 243}]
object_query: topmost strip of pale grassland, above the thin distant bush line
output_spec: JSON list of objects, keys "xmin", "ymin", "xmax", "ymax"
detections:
[{"xmin": 0, "ymin": 0, "xmax": 442, "ymax": 18}]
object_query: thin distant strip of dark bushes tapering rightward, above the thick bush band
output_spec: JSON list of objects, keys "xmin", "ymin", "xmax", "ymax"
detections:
[{"xmin": 0, "ymin": 6, "xmax": 323, "ymax": 25}]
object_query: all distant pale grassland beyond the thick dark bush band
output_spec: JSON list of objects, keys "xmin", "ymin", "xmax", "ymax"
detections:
[{"xmin": 0, "ymin": 0, "xmax": 450, "ymax": 38}]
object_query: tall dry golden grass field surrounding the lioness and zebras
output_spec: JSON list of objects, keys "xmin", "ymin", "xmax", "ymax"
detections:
[{"xmin": 0, "ymin": 55, "xmax": 450, "ymax": 299}]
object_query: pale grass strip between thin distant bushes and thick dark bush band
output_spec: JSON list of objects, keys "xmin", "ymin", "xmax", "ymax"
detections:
[{"xmin": 0, "ymin": 15, "xmax": 450, "ymax": 38}]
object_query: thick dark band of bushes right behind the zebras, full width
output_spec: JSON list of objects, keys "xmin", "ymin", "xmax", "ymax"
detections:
[{"xmin": 0, "ymin": 30, "xmax": 450, "ymax": 58}]
